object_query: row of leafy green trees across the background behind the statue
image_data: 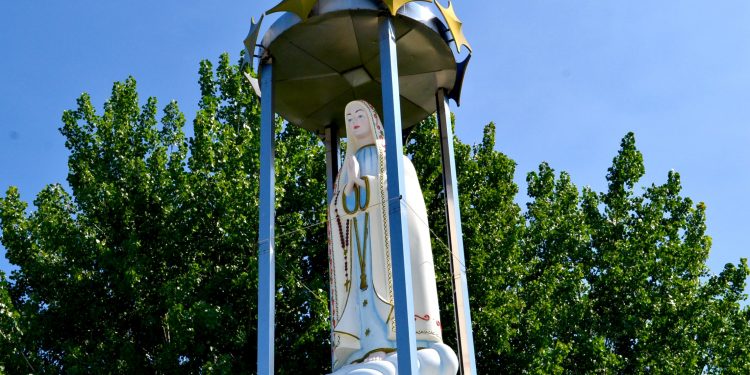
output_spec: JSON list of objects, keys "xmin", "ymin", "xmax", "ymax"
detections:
[{"xmin": 0, "ymin": 55, "xmax": 750, "ymax": 374}]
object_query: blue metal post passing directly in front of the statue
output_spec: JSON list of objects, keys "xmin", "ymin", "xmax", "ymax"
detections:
[{"xmin": 380, "ymin": 16, "xmax": 419, "ymax": 375}]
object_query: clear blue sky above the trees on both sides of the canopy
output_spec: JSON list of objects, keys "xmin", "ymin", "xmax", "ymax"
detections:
[{"xmin": 0, "ymin": 0, "xmax": 750, "ymax": 294}]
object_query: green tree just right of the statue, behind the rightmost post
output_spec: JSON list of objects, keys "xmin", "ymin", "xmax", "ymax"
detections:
[{"xmin": 405, "ymin": 118, "xmax": 525, "ymax": 373}]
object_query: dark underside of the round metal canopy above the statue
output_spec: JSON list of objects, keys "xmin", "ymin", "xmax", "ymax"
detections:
[{"xmin": 260, "ymin": 0, "xmax": 457, "ymax": 135}]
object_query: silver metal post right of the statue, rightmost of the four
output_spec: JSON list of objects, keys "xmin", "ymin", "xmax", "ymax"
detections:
[{"xmin": 436, "ymin": 90, "xmax": 477, "ymax": 375}]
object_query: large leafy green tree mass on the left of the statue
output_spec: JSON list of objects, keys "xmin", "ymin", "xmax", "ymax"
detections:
[{"xmin": 0, "ymin": 55, "xmax": 328, "ymax": 373}]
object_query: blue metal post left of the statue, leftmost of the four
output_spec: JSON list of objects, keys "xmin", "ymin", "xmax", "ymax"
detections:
[{"xmin": 258, "ymin": 63, "xmax": 276, "ymax": 375}]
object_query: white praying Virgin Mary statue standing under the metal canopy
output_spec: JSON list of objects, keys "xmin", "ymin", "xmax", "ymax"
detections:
[{"xmin": 328, "ymin": 101, "xmax": 458, "ymax": 375}]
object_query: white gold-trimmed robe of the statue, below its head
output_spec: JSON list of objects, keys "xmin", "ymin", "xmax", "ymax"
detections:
[{"xmin": 328, "ymin": 142, "xmax": 442, "ymax": 371}]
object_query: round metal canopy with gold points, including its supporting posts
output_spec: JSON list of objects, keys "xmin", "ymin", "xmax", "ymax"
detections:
[{"xmin": 251, "ymin": 0, "xmax": 476, "ymax": 375}]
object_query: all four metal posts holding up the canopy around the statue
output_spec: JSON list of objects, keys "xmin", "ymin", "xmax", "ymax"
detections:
[{"xmin": 258, "ymin": 21, "xmax": 476, "ymax": 375}]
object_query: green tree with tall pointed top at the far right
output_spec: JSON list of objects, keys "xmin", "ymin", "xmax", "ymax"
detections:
[{"xmin": 582, "ymin": 134, "xmax": 750, "ymax": 374}]
